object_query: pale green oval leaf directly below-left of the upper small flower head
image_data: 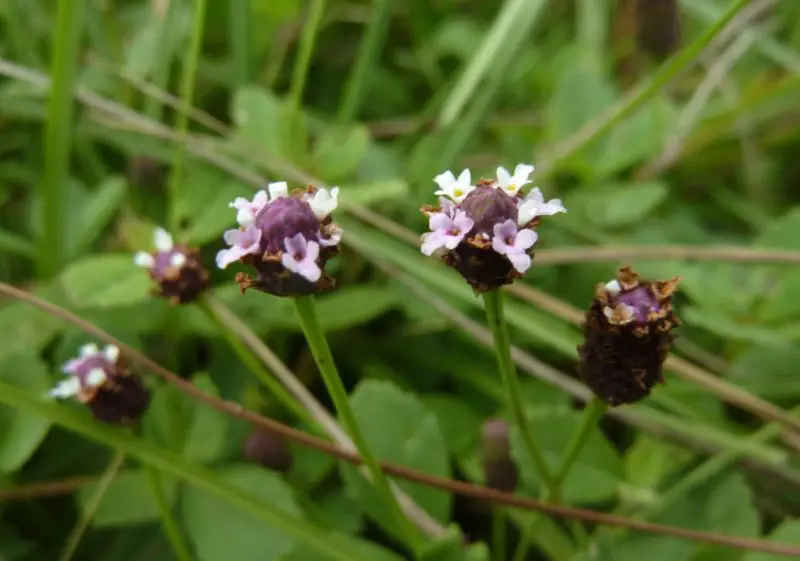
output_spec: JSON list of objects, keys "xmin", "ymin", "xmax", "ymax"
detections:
[{"xmin": 60, "ymin": 253, "xmax": 151, "ymax": 308}]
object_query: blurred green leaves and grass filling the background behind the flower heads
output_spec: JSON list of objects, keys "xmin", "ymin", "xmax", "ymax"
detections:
[{"xmin": 0, "ymin": 0, "xmax": 800, "ymax": 561}]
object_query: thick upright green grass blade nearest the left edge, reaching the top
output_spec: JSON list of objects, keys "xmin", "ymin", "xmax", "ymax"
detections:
[{"xmin": 38, "ymin": 0, "xmax": 86, "ymax": 278}]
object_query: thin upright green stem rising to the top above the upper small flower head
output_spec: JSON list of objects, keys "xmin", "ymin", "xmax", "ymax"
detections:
[{"xmin": 169, "ymin": 0, "xmax": 206, "ymax": 234}]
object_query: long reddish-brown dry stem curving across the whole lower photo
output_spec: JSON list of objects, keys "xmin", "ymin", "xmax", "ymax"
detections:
[{"xmin": 0, "ymin": 283, "xmax": 800, "ymax": 557}]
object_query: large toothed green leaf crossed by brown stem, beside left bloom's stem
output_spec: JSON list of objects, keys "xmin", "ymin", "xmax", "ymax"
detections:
[{"xmin": 341, "ymin": 380, "xmax": 452, "ymax": 533}]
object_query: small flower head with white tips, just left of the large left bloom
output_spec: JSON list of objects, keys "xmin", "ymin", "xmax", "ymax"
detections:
[{"xmin": 133, "ymin": 228, "xmax": 209, "ymax": 304}]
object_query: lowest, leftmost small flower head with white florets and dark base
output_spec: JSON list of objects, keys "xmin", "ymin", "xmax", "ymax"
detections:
[{"xmin": 50, "ymin": 344, "xmax": 150, "ymax": 424}]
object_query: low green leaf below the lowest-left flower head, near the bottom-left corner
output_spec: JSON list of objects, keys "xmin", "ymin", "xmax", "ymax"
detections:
[{"xmin": 80, "ymin": 470, "xmax": 177, "ymax": 527}]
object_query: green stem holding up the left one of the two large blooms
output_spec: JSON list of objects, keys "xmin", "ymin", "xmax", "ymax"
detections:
[{"xmin": 294, "ymin": 296, "xmax": 420, "ymax": 553}]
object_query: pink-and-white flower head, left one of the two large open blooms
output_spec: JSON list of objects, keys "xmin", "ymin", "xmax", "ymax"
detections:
[{"xmin": 217, "ymin": 182, "xmax": 342, "ymax": 296}]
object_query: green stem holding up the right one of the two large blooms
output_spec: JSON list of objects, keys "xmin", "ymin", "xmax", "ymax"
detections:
[{"xmin": 483, "ymin": 290, "xmax": 561, "ymax": 497}]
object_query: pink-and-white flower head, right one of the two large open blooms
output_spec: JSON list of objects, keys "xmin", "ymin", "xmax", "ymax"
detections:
[{"xmin": 421, "ymin": 164, "xmax": 567, "ymax": 292}]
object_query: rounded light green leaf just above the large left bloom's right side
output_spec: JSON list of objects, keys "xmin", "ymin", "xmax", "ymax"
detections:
[{"xmin": 313, "ymin": 125, "xmax": 369, "ymax": 183}]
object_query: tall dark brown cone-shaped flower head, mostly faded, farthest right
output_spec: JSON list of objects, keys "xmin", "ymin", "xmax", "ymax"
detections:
[{"xmin": 578, "ymin": 267, "xmax": 680, "ymax": 406}]
